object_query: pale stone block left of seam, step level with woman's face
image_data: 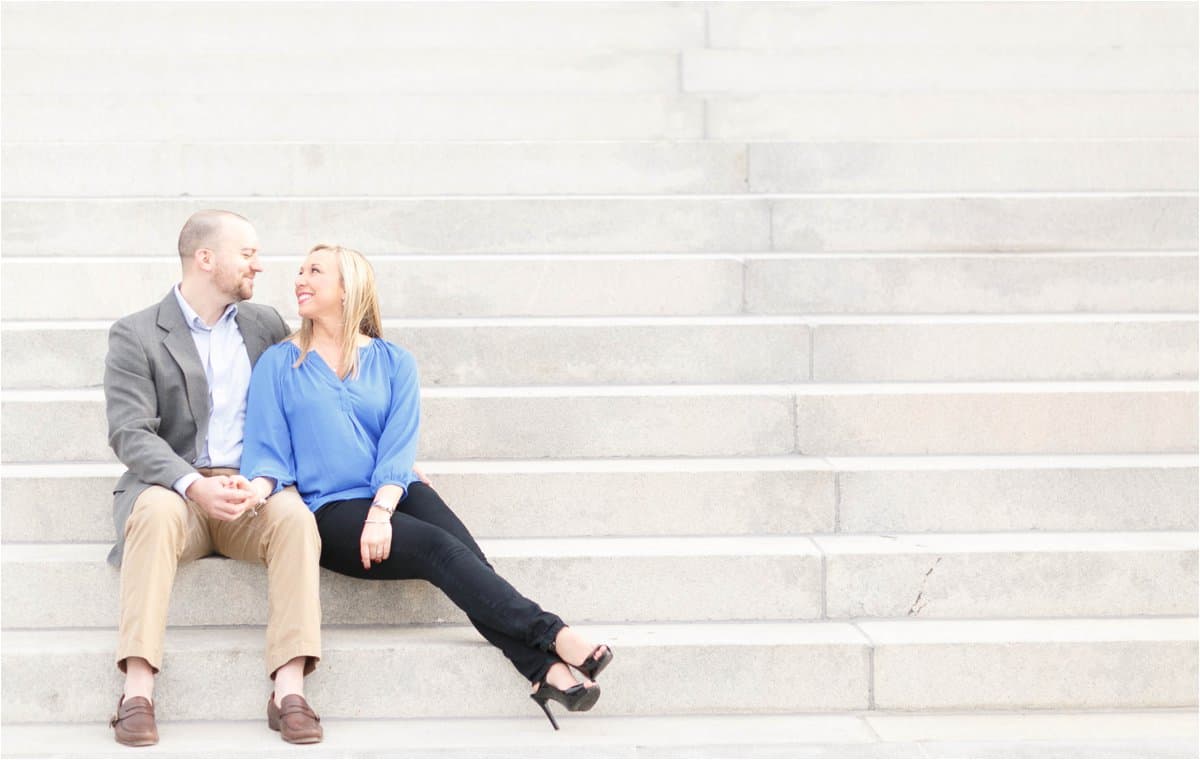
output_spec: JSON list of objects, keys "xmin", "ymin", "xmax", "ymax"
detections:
[{"xmin": 0, "ymin": 255, "xmax": 744, "ymax": 319}]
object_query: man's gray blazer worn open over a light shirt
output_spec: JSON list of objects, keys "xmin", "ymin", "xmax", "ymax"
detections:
[{"xmin": 104, "ymin": 291, "xmax": 288, "ymax": 567}]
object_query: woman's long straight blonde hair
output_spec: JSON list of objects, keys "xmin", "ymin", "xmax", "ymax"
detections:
[{"xmin": 292, "ymin": 243, "xmax": 383, "ymax": 379}]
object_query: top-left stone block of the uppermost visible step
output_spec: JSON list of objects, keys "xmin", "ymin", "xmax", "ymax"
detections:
[{"xmin": 4, "ymin": 2, "xmax": 704, "ymax": 51}]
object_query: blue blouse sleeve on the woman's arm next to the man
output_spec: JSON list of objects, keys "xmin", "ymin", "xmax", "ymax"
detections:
[{"xmin": 241, "ymin": 349, "xmax": 296, "ymax": 493}]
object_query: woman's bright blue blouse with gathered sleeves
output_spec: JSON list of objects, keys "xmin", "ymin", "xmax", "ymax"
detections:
[{"xmin": 241, "ymin": 339, "xmax": 421, "ymax": 511}]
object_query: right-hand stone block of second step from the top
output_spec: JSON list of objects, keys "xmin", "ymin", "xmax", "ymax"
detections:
[{"xmin": 681, "ymin": 47, "xmax": 1196, "ymax": 94}]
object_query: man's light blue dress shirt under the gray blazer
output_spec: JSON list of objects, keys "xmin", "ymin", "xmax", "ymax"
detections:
[{"xmin": 174, "ymin": 285, "xmax": 251, "ymax": 496}]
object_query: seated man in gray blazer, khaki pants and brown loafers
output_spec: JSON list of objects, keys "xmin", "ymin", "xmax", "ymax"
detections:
[{"xmin": 104, "ymin": 210, "xmax": 323, "ymax": 747}]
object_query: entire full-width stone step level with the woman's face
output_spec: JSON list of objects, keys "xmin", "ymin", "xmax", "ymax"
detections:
[{"xmin": 7, "ymin": 252, "xmax": 1200, "ymax": 316}]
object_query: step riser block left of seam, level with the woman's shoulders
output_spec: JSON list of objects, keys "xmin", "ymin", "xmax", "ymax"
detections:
[{"xmin": 2, "ymin": 324, "xmax": 816, "ymax": 388}]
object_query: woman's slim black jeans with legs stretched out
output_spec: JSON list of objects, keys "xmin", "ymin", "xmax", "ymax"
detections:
[{"xmin": 317, "ymin": 483, "xmax": 563, "ymax": 682}]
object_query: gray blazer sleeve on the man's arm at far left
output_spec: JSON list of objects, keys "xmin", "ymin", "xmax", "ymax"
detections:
[{"xmin": 104, "ymin": 321, "xmax": 196, "ymax": 489}]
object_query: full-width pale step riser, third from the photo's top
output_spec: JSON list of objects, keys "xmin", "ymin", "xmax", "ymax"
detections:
[{"xmin": 5, "ymin": 92, "xmax": 1196, "ymax": 143}]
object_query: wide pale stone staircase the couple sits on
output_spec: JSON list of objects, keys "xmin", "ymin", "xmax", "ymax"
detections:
[{"xmin": 0, "ymin": 2, "xmax": 1198, "ymax": 756}]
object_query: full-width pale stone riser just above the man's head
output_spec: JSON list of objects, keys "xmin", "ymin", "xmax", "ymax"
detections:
[{"xmin": 0, "ymin": 139, "xmax": 1196, "ymax": 198}]
